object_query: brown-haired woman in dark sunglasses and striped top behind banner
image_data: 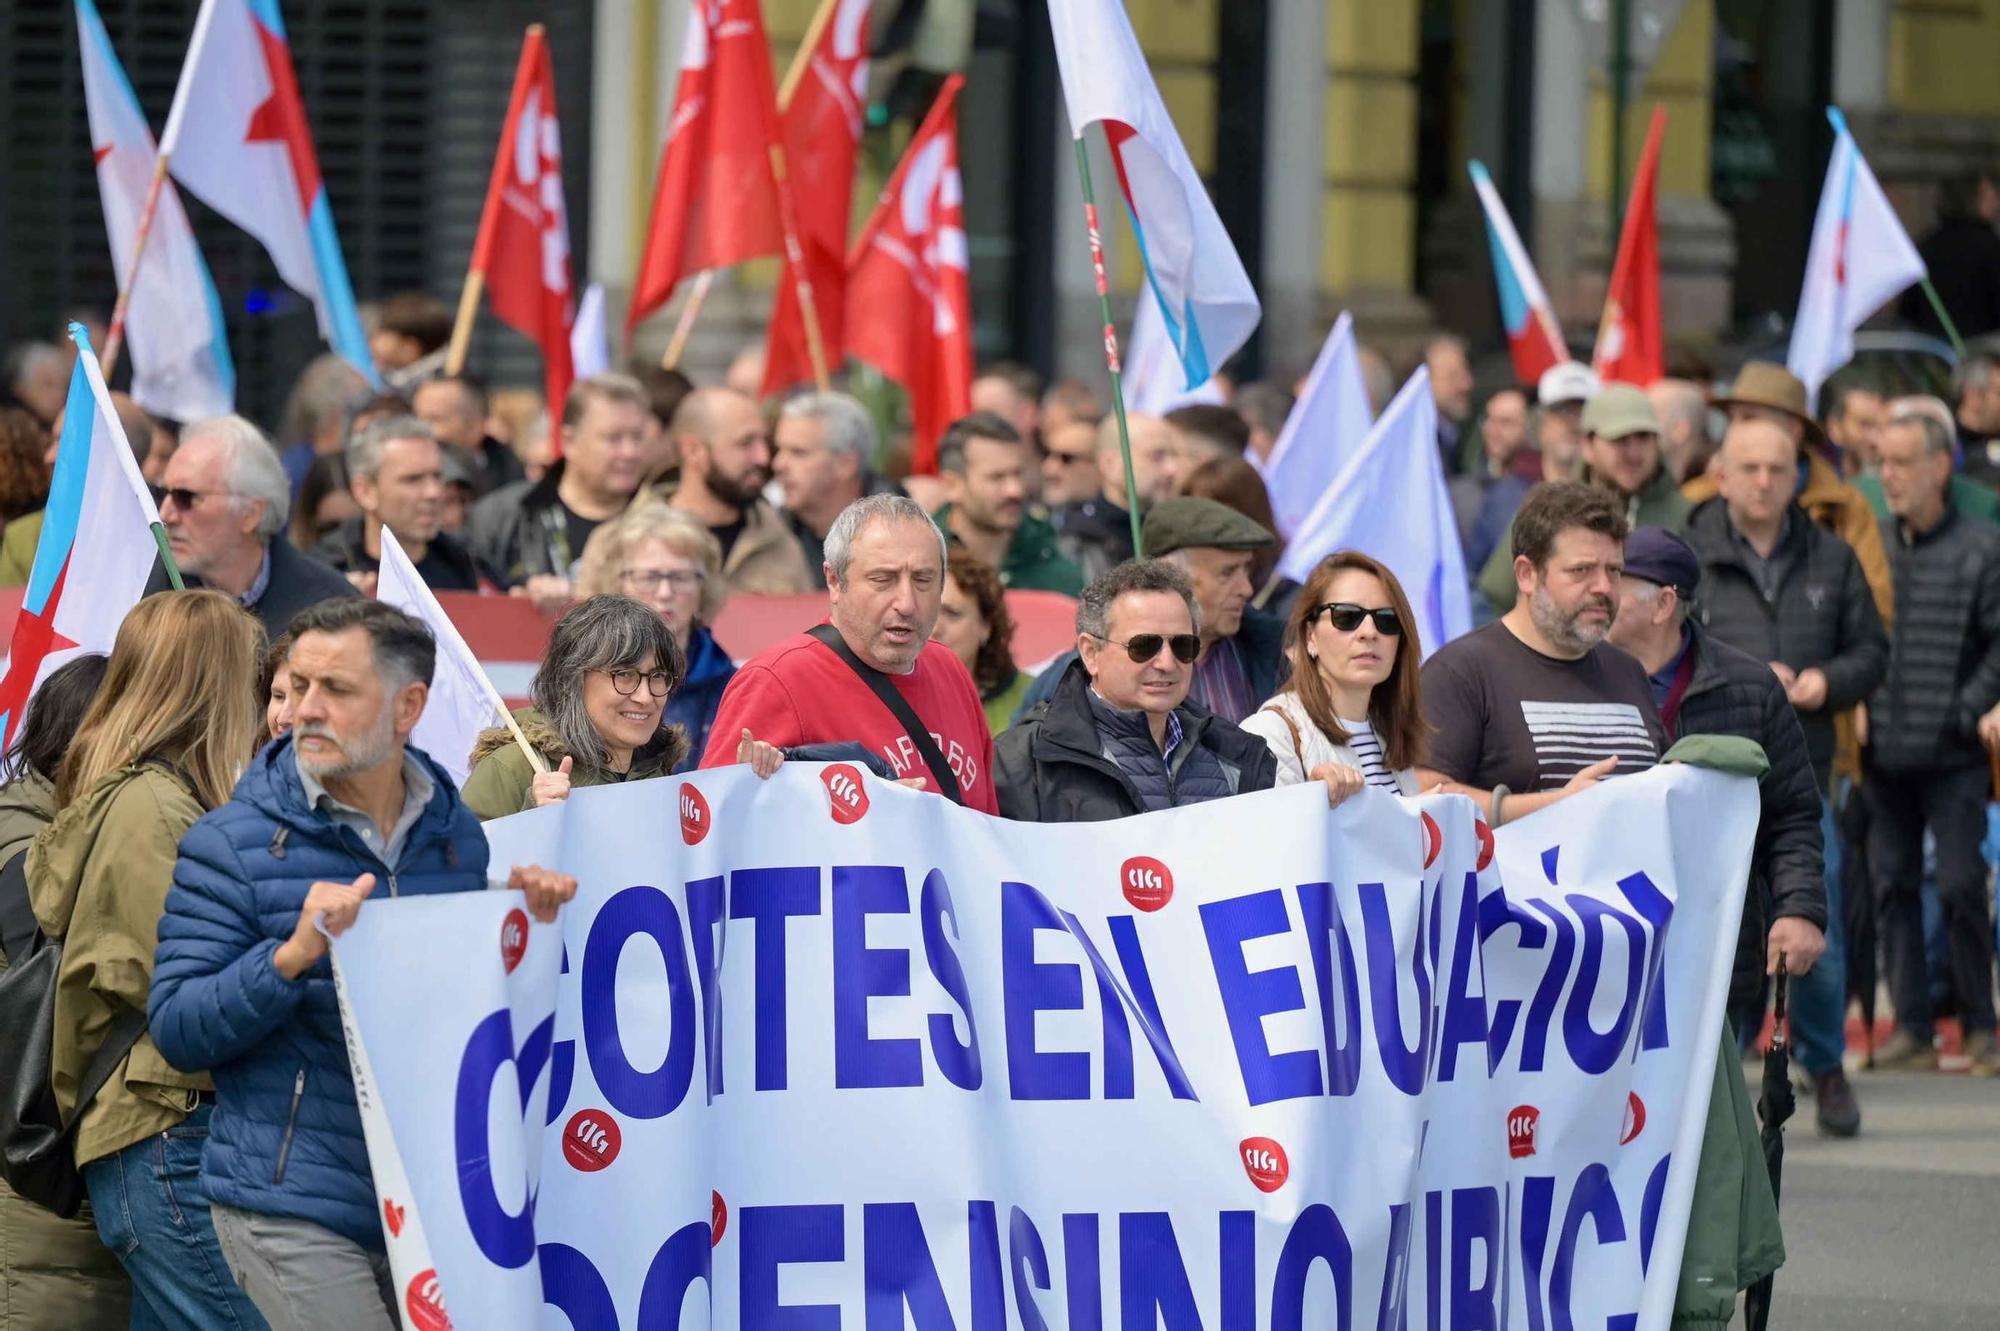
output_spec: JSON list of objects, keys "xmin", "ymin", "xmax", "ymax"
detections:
[{"xmin": 1244, "ymin": 550, "xmax": 1424, "ymax": 803}]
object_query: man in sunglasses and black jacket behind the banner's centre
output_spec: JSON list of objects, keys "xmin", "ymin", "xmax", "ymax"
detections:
[{"xmin": 994, "ymin": 560, "xmax": 1280, "ymax": 823}]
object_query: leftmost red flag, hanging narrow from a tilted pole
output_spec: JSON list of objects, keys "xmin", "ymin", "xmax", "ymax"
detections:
[{"xmin": 472, "ymin": 24, "xmax": 576, "ymax": 425}]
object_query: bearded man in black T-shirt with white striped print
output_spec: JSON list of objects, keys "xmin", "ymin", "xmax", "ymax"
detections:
[{"xmin": 1418, "ymin": 484, "xmax": 1666, "ymax": 827}]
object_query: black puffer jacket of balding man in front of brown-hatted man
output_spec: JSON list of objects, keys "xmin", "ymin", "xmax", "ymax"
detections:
[{"xmin": 1686, "ymin": 500, "xmax": 1888, "ymax": 789}]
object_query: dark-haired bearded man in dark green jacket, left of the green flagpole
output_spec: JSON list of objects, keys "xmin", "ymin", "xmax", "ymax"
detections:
[{"xmin": 938, "ymin": 412, "xmax": 1084, "ymax": 596}]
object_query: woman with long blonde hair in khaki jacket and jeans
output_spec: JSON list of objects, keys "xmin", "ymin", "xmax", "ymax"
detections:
[{"xmin": 28, "ymin": 592, "xmax": 264, "ymax": 1331}]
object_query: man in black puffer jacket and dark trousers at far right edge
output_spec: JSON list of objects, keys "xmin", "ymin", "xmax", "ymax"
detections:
[{"xmin": 1862, "ymin": 410, "xmax": 2000, "ymax": 1075}]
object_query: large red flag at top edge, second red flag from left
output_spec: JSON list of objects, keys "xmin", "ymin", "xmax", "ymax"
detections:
[{"xmin": 626, "ymin": 0, "xmax": 784, "ymax": 336}]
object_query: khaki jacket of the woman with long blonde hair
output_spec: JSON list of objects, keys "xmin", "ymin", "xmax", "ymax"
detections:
[{"xmin": 28, "ymin": 763, "xmax": 214, "ymax": 1165}]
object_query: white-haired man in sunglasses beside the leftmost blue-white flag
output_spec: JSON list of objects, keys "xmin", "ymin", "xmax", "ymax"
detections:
[{"xmin": 146, "ymin": 416, "xmax": 354, "ymax": 638}]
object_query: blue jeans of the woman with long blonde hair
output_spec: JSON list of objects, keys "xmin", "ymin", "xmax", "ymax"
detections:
[{"xmin": 84, "ymin": 1103, "xmax": 264, "ymax": 1331}]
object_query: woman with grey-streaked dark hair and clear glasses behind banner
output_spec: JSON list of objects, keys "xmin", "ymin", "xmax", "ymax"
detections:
[{"xmin": 460, "ymin": 596, "xmax": 688, "ymax": 819}]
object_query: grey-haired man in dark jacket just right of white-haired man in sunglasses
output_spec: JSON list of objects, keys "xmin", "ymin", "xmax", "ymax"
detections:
[{"xmin": 312, "ymin": 416, "xmax": 492, "ymax": 596}]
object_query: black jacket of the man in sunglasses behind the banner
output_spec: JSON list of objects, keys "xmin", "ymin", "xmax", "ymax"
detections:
[{"xmin": 994, "ymin": 662, "xmax": 1278, "ymax": 823}]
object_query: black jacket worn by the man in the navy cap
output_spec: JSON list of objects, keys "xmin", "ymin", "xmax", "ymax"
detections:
[{"xmin": 1668, "ymin": 624, "xmax": 1826, "ymax": 1011}]
